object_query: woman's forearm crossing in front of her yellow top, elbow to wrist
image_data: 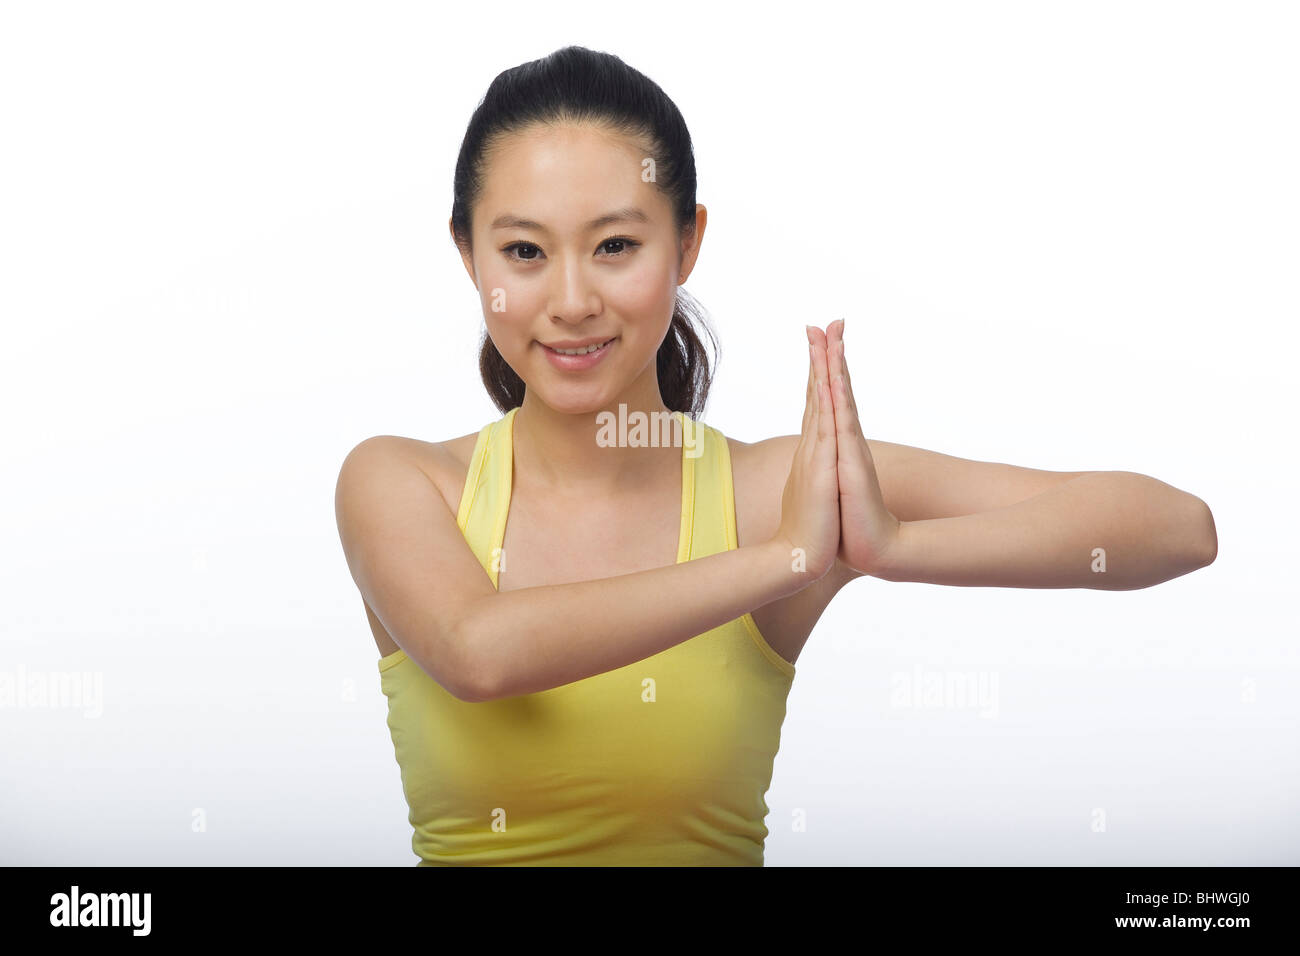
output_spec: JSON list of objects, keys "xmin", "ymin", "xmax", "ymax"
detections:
[{"xmin": 458, "ymin": 541, "xmax": 810, "ymax": 700}]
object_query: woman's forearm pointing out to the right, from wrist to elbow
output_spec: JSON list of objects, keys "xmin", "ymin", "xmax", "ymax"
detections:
[{"xmin": 871, "ymin": 471, "xmax": 1218, "ymax": 591}]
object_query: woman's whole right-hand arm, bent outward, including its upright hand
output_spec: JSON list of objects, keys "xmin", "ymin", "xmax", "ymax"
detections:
[{"xmin": 828, "ymin": 321, "xmax": 1218, "ymax": 591}]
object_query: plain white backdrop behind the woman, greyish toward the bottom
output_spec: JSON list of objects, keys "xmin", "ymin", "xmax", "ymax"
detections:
[{"xmin": 0, "ymin": 0, "xmax": 1300, "ymax": 865}]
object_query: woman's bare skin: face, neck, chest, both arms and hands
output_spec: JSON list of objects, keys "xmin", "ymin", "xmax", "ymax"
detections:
[{"xmin": 337, "ymin": 125, "xmax": 1217, "ymax": 700}]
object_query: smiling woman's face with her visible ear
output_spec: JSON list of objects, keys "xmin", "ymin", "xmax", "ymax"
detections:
[{"xmin": 454, "ymin": 125, "xmax": 705, "ymax": 414}]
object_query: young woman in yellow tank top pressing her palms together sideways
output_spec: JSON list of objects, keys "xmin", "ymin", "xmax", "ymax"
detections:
[{"xmin": 337, "ymin": 47, "xmax": 1217, "ymax": 865}]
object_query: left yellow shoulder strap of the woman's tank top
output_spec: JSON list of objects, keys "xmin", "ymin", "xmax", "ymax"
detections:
[{"xmin": 456, "ymin": 406, "xmax": 519, "ymax": 588}]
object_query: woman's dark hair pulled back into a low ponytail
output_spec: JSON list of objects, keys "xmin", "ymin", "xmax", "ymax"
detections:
[{"xmin": 451, "ymin": 47, "xmax": 718, "ymax": 419}]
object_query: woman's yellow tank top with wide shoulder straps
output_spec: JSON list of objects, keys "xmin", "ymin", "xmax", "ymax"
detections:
[{"xmin": 378, "ymin": 408, "xmax": 794, "ymax": 866}]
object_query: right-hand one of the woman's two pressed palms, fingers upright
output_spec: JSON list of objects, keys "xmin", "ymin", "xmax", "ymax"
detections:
[{"xmin": 813, "ymin": 319, "xmax": 901, "ymax": 575}]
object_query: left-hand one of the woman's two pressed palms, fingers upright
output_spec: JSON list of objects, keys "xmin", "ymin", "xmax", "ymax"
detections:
[{"xmin": 774, "ymin": 326, "xmax": 840, "ymax": 584}]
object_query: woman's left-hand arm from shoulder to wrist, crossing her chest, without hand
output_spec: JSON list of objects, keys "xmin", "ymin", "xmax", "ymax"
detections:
[{"xmin": 335, "ymin": 460, "xmax": 816, "ymax": 701}]
